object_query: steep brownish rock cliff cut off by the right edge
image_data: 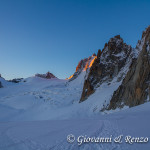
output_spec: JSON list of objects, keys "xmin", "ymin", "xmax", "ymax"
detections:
[{"xmin": 108, "ymin": 26, "xmax": 150, "ymax": 109}]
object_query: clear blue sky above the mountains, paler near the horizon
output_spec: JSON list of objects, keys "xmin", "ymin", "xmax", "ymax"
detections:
[{"xmin": 0, "ymin": 0, "xmax": 150, "ymax": 79}]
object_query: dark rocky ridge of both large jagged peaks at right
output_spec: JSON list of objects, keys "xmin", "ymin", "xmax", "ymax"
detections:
[{"xmin": 76, "ymin": 26, "xmax": 150, "ymax": 111}]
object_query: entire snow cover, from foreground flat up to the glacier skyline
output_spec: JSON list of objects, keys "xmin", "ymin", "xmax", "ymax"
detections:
[{"xmin": 0, "ymin": 77, "xmax": 150, "ymax": 150}]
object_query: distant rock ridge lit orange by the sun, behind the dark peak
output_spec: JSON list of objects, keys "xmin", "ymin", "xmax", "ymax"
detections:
[{"xmin": 68, "ymin": 54, "xmax": 97, "ymax": 81}]
